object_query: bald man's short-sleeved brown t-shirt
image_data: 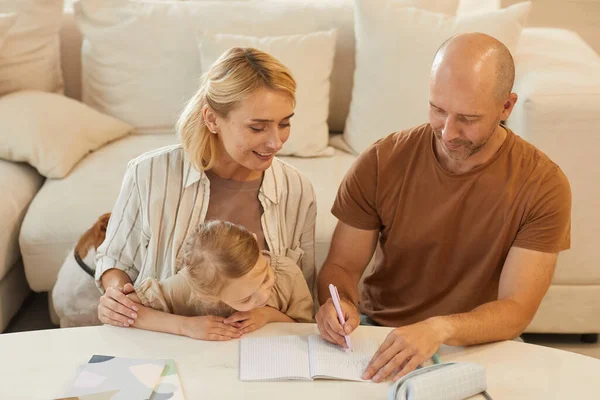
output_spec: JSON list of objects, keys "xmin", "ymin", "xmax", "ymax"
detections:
[{"xmin": 332, "ymin": 124, "xmax": 571, "ymax": 326}]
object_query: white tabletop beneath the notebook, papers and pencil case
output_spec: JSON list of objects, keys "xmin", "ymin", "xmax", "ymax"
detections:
[{"xmin": 0, "ymin": 323, "xmax": 600, "ymax": 400}]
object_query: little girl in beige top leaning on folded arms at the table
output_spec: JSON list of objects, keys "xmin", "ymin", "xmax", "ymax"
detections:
[{"xmin": 125, "ymin": 221, "xmax": 313, "ymax": 340}]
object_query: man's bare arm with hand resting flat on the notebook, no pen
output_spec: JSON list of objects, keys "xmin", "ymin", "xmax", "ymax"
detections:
[{"xmin": 363, "ymin": 247, "xmax": 557, "ymax": 382}]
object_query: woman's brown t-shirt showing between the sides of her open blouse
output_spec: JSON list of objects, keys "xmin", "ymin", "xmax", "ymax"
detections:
[{"xmin": 204, "ymin": 171, "xmax": 268, "ymax": 250}]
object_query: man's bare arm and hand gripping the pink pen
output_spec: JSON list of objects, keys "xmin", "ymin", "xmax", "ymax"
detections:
[{"xmin": 315, "ymin": 221, "xmax": 379, "ymax": 347}]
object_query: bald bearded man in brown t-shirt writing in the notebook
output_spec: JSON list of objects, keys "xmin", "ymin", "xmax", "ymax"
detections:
[{"xmin": 316, "ymin": 34, "xmax": 571, "ymax": 382}]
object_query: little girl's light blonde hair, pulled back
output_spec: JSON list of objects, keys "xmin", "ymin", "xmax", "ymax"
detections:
[{"xmin": 179, "ymin": 221, "xmax": 260, "ymax": 301}]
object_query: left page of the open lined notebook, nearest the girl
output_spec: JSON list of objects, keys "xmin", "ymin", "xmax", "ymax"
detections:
[{"xmin": 240, "ymin": 336, "xmax": 310, "ymax": 381}]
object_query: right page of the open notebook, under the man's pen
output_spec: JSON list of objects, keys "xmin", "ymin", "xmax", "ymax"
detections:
[{"xmin": 308, "ymin": 335, "xmax": 379, "ymax": 381}]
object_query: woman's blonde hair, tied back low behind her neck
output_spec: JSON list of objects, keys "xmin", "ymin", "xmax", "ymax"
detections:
[{"xmin": 176, "ymin": 47, "xmax": 296, "ymax": 171}]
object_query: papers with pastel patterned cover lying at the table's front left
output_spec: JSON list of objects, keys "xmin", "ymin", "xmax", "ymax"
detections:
[{"xmin": 59, "ymin": 355, "xmax": 185, "ymax": 400}]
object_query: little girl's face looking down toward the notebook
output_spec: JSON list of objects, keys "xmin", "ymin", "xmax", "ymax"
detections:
[{"xmin": 221, "ymin": 253, "xmax": 275, "ymax": 311}]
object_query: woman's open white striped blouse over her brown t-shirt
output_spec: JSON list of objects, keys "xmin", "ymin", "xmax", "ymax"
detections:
[{"xmin": 96, "ymin": 144, "xmax": 317, "ymax": 293}]
